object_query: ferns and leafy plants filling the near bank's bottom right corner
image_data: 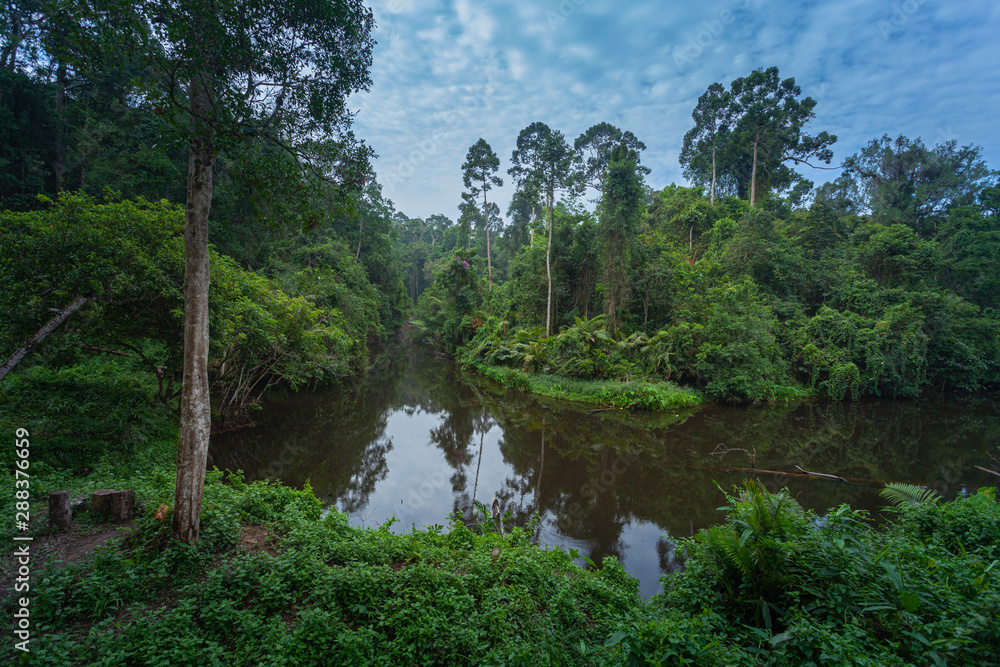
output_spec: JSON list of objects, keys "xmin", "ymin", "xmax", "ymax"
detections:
[{"xmin": 640, "ymin": 484, "xmax": 1000, "ymax": 666}]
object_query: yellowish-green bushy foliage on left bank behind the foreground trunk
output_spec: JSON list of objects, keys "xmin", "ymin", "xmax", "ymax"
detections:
[{"xmin": 0, "ymin": 194, "xmax": 379, "ymax": 422}]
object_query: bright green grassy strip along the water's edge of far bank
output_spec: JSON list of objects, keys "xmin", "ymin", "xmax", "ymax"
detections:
[{"xmin": 468, "ymin": 362, "xmax": 705, "ymax": 411}]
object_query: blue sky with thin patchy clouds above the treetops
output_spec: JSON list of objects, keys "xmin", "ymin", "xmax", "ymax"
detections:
[{"xmin": 352, "ymin": 0, "xmax": 1000, "ymax": 219}]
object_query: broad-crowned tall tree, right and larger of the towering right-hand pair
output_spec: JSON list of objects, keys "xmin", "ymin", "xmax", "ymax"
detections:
[{"xmin": 730, "ymin": 67, "xmax": 837, "ymax": 206}]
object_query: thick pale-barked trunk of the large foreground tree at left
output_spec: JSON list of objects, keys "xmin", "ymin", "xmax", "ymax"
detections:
[{"xmin": 172, "ymin": 76, "xmax": 216, "ymax": 544}]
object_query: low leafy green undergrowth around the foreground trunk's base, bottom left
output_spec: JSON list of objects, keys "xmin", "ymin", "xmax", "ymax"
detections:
[{"xmin": 4, "ymin": 472, "xmax": 642, "ymax": 665}]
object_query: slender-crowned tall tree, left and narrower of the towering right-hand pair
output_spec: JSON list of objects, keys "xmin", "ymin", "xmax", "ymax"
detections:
[{"xmin": 680, "ymin": 83, "xmax": 734, "ymax": 206}]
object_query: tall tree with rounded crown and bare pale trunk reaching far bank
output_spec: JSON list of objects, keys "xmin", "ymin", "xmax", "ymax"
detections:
[{"xmin": 507, "ymin": 122, "xmax": 578, "ymax": 336}]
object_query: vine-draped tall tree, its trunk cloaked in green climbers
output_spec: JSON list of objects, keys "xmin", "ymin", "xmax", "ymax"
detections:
[{"xmin": 598, "ymin": 142, "xmax": 645, "ymax": 335}]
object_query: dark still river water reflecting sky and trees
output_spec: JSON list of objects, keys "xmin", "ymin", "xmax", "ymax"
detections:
[{"xmin": 209, "ymin": 347, "xmax": 1000, "ymax": 596}]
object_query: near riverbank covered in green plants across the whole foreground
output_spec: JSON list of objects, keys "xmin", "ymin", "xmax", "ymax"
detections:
[{"xmin": 2, "ymin": 428, "xmax": 1000, "ymax": 665}]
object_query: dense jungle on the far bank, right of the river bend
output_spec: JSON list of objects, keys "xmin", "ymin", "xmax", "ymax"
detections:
[{"xmin": 406, "ymin": 121, "xmax": 1000, "ymax": 403}]
